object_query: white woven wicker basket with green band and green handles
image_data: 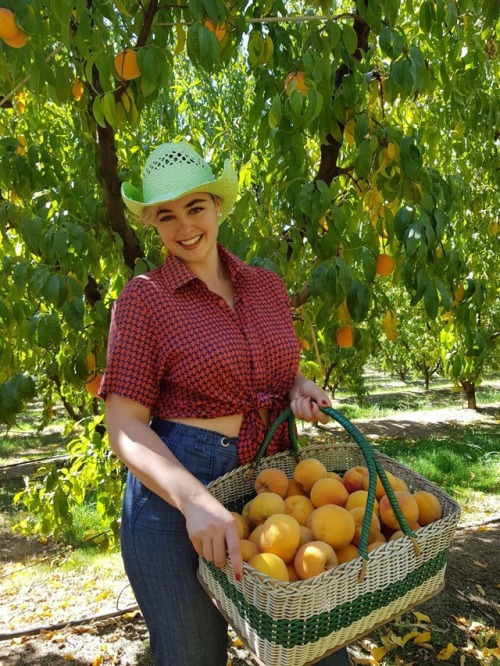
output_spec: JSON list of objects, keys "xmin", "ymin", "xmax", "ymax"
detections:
[{"xmin": 198, "ymin": 407, "xmax": 460, "ymax": 666}]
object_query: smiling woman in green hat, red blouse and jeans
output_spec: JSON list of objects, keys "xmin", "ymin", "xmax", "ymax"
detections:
[{"xmin": 101, "ymin": 142, "xmax": 348, "ymax": 666}]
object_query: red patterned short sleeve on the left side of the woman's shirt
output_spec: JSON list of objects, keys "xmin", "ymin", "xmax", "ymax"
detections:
[{"xmin": 99, "ymin": 278, "xmax": 159, "ymax": 409}]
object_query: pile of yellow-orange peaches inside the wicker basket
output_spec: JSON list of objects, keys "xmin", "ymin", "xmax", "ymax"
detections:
[{"xmin": 232, "ymin": 458, "xmax": 442, "ymax": 582}]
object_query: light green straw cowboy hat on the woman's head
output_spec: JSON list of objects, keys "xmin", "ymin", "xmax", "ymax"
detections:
[{"xmin": 121, "ymin": 141, "xmax": 238, "ymax": 222}]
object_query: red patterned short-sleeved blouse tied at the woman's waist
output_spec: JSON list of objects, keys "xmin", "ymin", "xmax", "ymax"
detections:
[{"xmin": 100, "ymin": 245, "xmax": 300, "ymax": 464}]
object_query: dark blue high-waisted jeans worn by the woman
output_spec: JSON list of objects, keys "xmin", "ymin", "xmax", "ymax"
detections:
[{"xmin": 121, "ymin": 420, "xmax": 349, "ymax": 666}]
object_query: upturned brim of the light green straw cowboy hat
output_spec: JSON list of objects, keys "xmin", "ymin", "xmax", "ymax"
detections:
[{"xmin": 121, "ymin": 160, "xmax": 238, "ymax": 222}]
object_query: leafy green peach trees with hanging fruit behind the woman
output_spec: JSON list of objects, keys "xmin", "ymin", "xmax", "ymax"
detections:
[{"xmin": 0, "ymin": 0, "xmax": 500, "ymax": 536}]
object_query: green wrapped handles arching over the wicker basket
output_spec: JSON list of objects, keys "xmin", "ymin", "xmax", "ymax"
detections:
[{"xmin": 248, "ymin": 407, "xmax": 420, "ymax": 580}]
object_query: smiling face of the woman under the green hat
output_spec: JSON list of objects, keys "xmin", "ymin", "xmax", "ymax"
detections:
[{"xmin": 154, "ymin": 192, "xmax": 220, "ymax": 265}]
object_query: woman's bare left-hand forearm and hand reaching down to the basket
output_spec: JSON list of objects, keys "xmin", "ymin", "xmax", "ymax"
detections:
[{"xmin": 106, "ymin": 393, "xmax": 243, "ymax": 578}]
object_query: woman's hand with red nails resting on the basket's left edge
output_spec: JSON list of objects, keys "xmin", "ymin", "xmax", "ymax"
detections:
[{"xmin": 182, "ymin": 491, "xmax": 243, "ymax": 580}]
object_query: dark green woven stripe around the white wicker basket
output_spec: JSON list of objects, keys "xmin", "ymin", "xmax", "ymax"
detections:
[{"xmin": 207, "ymin": 548, "xmax": 448, "ymax": 648}]
